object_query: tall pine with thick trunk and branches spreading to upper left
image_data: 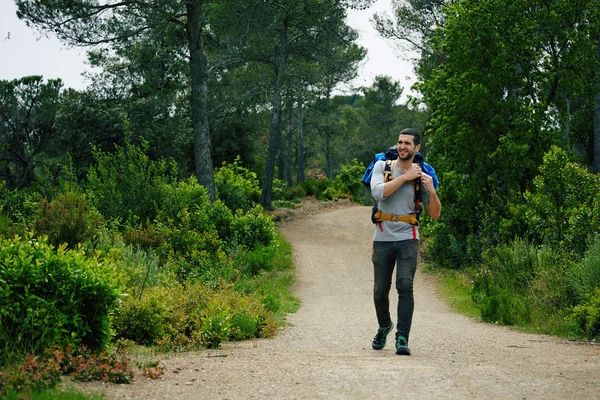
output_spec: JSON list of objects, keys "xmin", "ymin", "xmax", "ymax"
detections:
[{"xmin": 16, "ymin": 0, "xmax": 215, "ymax": 200}]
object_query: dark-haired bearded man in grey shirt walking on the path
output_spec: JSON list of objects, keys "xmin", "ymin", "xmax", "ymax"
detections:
[{"xmin": 371, "ymin": 129, "xmax": 442, "ymax": 355}]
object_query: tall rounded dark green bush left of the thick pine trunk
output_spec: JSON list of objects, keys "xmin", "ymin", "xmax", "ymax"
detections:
[{"xmin": 86, "ymin": 144, "xmax": 177, "ymax": 226}]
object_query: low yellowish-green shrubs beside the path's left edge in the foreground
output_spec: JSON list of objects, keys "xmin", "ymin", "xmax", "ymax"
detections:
[{"xmin": 114, "ymin": 282, "xmax": 274, "ymax": 350}]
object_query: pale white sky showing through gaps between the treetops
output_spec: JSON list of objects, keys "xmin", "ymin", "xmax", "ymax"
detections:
[{"xmin": 0, "ymin": 0, "xmax": 415, "ymax": 97}]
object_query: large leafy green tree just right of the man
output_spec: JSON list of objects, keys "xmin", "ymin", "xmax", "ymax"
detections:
[{"xmin": 417, "ymin": 0, "xmax": 600, "ymax": 267}]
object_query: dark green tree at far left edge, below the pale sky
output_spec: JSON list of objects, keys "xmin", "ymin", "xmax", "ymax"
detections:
[{"xmin": 0, "ymin": 76, "xmax": 62, "ymax": 188}]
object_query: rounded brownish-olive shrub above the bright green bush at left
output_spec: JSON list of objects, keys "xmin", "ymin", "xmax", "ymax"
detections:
[{"xmin": 35, "ymin": 190, "xmax": 101, "ymax": 248}]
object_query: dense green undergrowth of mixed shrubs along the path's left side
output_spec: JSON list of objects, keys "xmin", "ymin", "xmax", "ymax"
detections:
[{"xmin": 0, "ymin": 145, "xmax": 361, "ymax": 398}]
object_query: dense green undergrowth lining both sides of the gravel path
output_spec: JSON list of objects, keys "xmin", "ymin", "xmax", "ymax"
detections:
[{"xmin": 0, "ymin": 145, "xmax": 600, "ymax": 398}]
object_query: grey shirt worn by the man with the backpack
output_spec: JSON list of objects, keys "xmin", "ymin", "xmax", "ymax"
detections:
[{"xmin": 371, "ymin": 161, "xmax": 429, "ymax": 242}]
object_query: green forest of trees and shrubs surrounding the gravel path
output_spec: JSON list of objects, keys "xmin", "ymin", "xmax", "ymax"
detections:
[{"xmin": 0, "ymin": 0, "xmax": 600, "ymax": 392}]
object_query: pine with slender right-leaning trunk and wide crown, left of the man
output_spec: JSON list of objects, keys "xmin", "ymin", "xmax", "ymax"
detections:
[{"xmin": 211, "ymin": 0, "xmax": 364, "ymax": 207}]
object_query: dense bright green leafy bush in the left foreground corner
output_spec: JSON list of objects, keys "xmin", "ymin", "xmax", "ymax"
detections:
[{"xmin": 0, "ymin": 238, "xmax": 119, "ymax": 368}]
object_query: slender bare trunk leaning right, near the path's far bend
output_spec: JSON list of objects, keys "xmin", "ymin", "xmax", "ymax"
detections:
[{"xmin": 260, "ymin": 22, "xmax": 288, "ymax": 209}]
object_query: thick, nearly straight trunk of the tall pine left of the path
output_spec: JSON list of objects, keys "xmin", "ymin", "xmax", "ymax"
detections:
[{"xmin": 186, "ymin": 0, "xmax": 216, "ymax": 201}]
